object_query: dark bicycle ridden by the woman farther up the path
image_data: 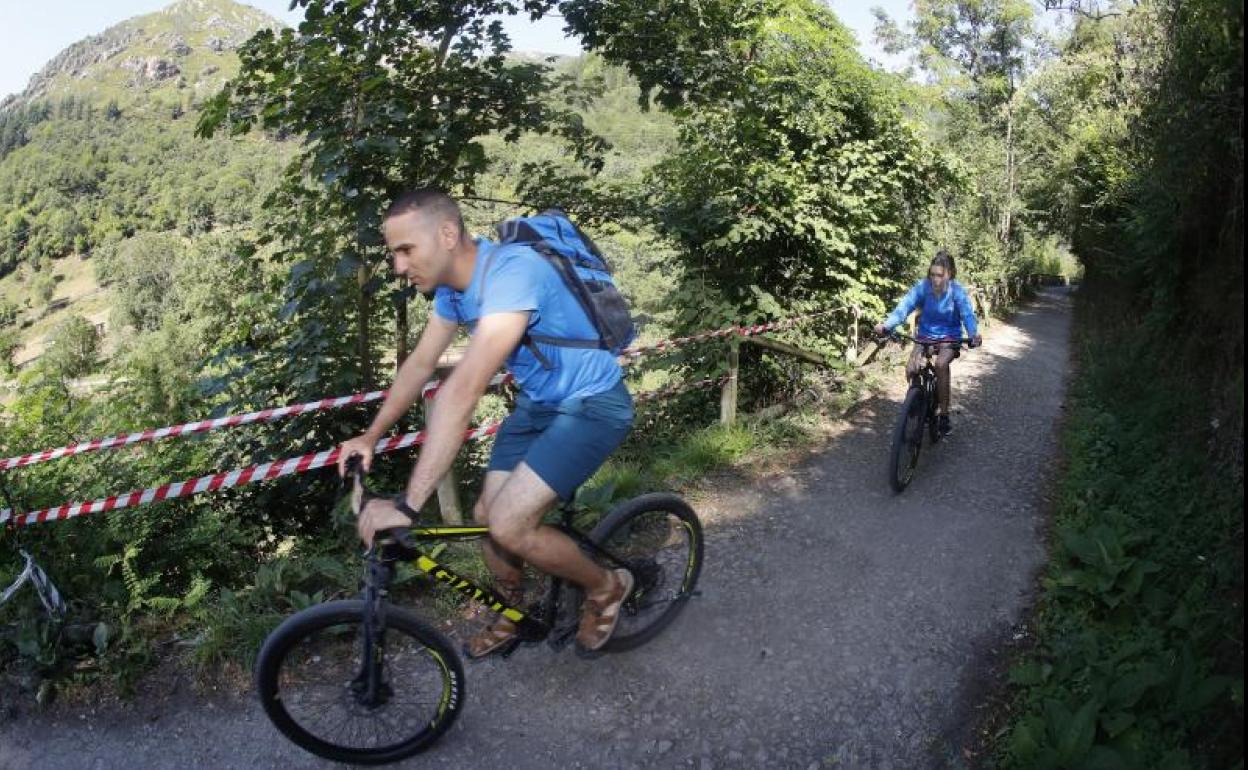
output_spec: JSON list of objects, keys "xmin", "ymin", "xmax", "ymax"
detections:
[{"xmin": 886, "ymin": 332, "xmax": 975, "ymax": 493}]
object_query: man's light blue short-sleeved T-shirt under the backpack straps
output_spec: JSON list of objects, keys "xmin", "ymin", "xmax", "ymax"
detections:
[{"xmin": 433, "ymin": 238, "xmax": 623, "ymax": 403}]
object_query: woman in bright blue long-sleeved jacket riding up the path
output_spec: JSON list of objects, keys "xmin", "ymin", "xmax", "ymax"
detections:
[{"xmin": 875, "ymin": 250, "xmax": 983, "ymax": 436}]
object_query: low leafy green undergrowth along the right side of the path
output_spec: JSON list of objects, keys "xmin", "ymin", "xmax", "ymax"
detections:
[{"xmin": 1002, "ymin": 310, "xmax": 1243, "ymax": 770}]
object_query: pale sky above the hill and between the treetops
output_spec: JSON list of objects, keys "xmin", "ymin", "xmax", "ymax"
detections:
[{"xmin": 0, "ymin": 0, "xmax": 910, "ymax": 99}]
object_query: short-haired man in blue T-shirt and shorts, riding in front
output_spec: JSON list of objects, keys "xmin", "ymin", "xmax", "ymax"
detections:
[{"xmin": 338, "ymin": 188, "xmax": 633, "ymax": 658}]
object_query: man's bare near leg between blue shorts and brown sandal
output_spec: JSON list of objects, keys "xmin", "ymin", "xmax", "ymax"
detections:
[{"xmin": 485, "ymin": 463, "xmax": 615, "ymax": 600}]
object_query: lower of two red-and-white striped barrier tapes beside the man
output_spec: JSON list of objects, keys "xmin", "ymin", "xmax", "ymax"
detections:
[{"xmin": 0, "ymin": 377, "xmax": 726, "ymax": 527}]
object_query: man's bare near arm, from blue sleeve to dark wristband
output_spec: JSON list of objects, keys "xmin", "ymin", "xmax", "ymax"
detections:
[{"xmin": 407, "ymin": 311, "xmax": 529, "ymax": 510}]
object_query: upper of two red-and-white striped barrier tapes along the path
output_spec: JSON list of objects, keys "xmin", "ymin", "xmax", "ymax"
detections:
[{"xmin": 0, "ymin": 307, "xmax": 847, "ymax": 470}]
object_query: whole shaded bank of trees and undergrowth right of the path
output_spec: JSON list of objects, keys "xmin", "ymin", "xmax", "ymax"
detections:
[{"xmin": 1000, "ymin": 0, "xmax": 1244, "ymax": 770}]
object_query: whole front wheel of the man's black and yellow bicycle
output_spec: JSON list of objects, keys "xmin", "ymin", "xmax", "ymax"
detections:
[{"xmin": 256, "ymin": 599, "xmax": 464, "ymax": 765}]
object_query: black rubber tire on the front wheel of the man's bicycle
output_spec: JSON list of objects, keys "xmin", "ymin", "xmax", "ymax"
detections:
[{"xmin": 256, "ymin": 599, "xmax": 464, "ymax": 765}]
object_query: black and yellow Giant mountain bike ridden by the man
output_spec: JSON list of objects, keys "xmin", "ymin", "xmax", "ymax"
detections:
[{"xmin": 256, "ymin": 459, "xmax": 703, "ymax": 765}]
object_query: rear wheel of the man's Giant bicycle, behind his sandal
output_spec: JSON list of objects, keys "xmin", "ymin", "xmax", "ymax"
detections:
[{"xmin": 589, "ymin": 492, "xmax": 704, "ymax": 653}]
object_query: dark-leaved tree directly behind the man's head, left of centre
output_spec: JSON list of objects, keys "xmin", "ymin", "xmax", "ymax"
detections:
[{"xmin": 198, "ymin": 0, "xmax": 603, "ymax": 388}]
